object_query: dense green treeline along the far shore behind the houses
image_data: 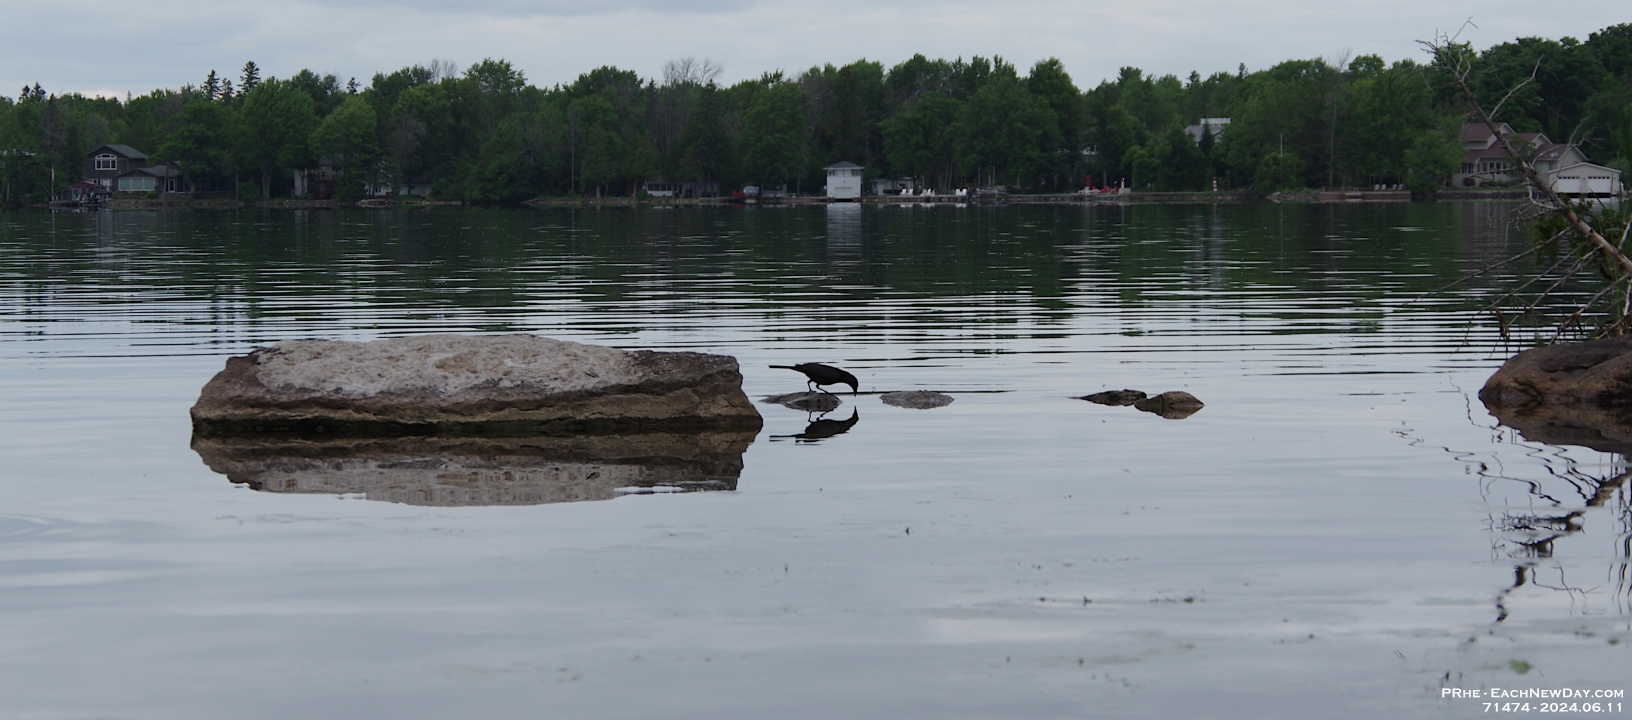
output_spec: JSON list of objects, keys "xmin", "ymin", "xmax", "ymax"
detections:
[{"xmin": 0, "ymin": 24, "xmax": 1632, "ymax": 204}]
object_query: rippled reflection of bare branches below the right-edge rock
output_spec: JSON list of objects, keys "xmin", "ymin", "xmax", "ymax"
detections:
[{"xmin": 1395, "ymin": 413, "xmax": 1632, "ymax": 622}]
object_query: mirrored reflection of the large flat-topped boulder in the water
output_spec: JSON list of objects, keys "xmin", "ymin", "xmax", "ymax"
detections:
[{"xmin": 193, "ymin": 433, "xmax": 756, "ymax": 506}]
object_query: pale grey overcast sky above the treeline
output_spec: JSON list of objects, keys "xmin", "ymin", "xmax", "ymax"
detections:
[{"xmin": 0, "ymin": 0, "xmax": 1632, "ymax": 96}]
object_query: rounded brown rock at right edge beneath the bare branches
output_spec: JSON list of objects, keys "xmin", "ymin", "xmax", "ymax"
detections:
[{"xmin": 1479, "ymin": 338, "xmax": 1632, "ymax": 454}]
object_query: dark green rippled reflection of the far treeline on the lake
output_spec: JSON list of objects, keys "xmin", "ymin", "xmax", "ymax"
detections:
[{"xmin": 0, "ymin": 202, "xmax": 1523, "ymax": 343}]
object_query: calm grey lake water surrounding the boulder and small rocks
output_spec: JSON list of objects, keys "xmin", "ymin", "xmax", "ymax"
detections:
[{"xmin": 0, "ymin": 204, "xmax": 1632, "ymax": 718}]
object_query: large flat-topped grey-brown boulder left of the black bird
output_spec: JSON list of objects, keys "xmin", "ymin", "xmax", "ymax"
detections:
[{"xmin": 191, "ymin": 335, "xmax": 761, "ymax": 436}]
